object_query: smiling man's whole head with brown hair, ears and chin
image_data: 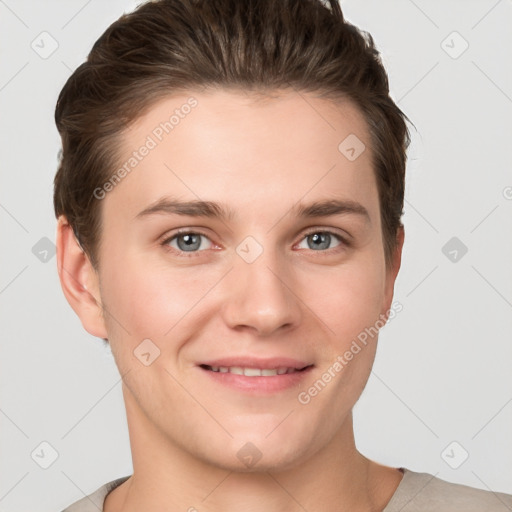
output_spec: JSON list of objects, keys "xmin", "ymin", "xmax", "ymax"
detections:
[{"xmin": 54, "ymin": 0, "xmax": 409, "ymax": 467}]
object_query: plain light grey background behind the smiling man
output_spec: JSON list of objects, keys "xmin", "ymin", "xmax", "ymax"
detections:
[{"xmin": 0, "ymin": 0, "xmax": 512, "ymax": 512}]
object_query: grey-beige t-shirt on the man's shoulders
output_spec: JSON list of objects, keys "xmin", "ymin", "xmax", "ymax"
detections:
[{"xmin": 62, "ymin": 468, "xmax": 512, "ymax": 512}]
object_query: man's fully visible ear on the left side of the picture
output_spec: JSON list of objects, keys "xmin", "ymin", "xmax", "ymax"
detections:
[{"xmin": 56, "ymin": 215, "xmax": 108, "ymax": 339}]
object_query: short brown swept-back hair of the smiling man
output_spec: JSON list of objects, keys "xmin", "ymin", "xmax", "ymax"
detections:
[{"xmin": 54, "ymin": 0, "xmax": 410, "ymax": 268}]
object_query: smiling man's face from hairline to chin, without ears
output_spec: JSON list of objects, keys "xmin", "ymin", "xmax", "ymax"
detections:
[{"xmin": 94, "ymin": 91, "xmax": 402, "ymax": 470}]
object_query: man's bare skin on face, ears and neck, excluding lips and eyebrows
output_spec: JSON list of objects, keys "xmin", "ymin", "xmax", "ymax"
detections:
[{"xmin": 57, "ymin": 90, "xmax": 404, "ymax": 512}]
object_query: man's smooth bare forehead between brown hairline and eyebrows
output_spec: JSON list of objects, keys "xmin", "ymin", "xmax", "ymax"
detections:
[{"xmin": 103, "ymin": 90, "xmax": 378, "ymax": 227}]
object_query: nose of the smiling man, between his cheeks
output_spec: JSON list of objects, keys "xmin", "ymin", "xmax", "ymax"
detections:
[{"xmin": 222, "ymin": 246, "xmax": 301, "ymax": 337}]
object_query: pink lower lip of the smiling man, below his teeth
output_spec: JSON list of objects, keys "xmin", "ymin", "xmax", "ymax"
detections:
[{"xmin": 198, "ymin": 366, "xmax": 313, "ymax": 393}]
